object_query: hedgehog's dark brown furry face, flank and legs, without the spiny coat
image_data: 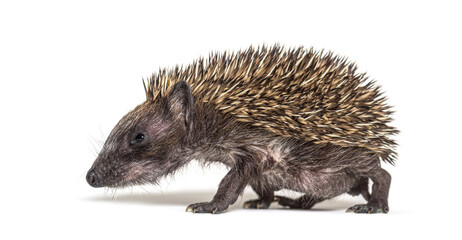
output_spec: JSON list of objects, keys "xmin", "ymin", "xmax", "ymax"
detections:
[{"xmin": 87, "ymin": 46, "xmax": 398, "ymax": 213}]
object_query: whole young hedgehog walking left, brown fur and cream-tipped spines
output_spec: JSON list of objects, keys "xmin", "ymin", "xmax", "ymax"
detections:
[{"xmin": 86, "ymin": 46, "xmax": 398, "ymax": 213}]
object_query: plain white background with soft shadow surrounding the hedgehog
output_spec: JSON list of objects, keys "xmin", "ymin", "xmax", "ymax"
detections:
[{"xmin": 0, "ymin": 1, "xmax": 462, "ymax": 239}]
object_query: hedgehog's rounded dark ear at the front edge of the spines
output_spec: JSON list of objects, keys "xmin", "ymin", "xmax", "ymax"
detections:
[{"xmin": 167, "ymin": 81, "xmax": 194, "ymax": 130}]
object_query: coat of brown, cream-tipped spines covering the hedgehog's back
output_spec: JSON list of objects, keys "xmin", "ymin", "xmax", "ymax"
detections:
[{"xmin": 146, "ymin": 46, "xmax": 397, "ymax": 163}]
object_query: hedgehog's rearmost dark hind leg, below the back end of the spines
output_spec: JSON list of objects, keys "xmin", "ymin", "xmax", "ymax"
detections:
[{"xmin": 347, "ymin": 168, "xmax": 391, "ymax": 213}]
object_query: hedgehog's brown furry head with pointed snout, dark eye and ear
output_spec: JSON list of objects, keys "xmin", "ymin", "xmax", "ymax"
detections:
[{"xmin": 87, "ymin": 81, "xmax": 194, "ymax": 187}]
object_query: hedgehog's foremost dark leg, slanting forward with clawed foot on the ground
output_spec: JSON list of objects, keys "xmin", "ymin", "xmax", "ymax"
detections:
[{"xmin": 186, "ymin": 167, "xmax": 248, "ymax": 214}]
